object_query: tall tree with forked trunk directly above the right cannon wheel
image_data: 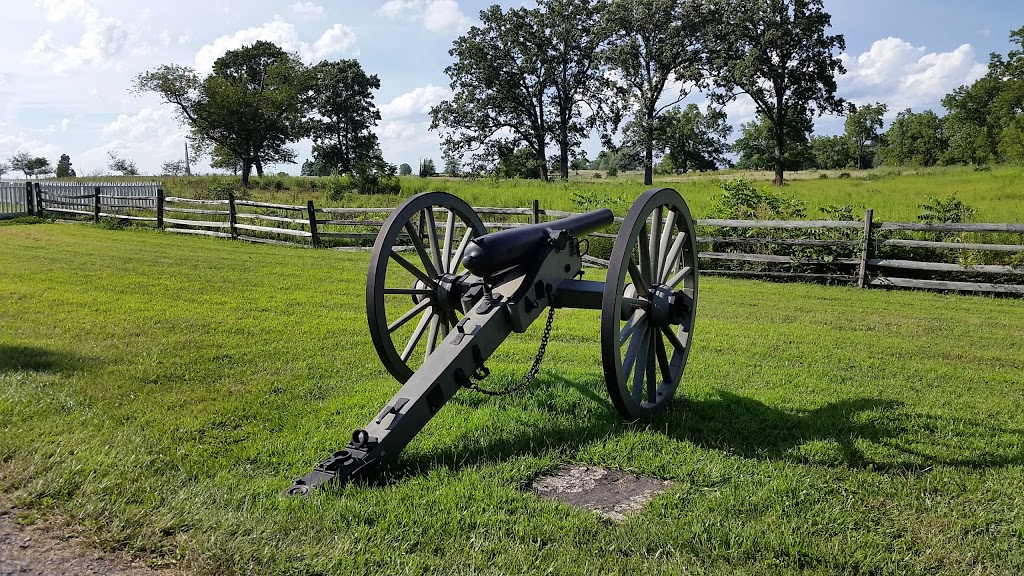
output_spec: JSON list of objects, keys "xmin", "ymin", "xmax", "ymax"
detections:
[{"xmin": 601, "ymin": 0, "xmax": 706, "ymax": 186}]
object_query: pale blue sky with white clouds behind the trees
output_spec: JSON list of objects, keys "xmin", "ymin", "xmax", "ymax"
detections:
[{"xmin": 0, "ymin": 0, "xmax": 1024, "ymax": 177}]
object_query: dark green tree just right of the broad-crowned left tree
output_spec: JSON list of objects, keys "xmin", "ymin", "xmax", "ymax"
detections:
[{"xmin": 305, "ymin": 59, "xmax": 381, "ymax": 174}]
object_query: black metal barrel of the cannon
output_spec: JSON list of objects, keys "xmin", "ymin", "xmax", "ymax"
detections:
[{"xmin": 462, "ymin": 208, "xmax": 614, "ymax": 277}]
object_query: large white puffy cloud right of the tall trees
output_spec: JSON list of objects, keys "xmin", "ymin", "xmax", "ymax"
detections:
[{"xmin": 839, "ymin": 37, "xmax": 988, "ymax": 114}]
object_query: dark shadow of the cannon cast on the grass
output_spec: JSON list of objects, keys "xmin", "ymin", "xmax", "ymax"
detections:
[{"xmin": 387, "ymin": 375, "xmax": 1024, "ymax": 481}]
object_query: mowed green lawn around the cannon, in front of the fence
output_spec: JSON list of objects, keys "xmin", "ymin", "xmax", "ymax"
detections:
[{"xmin": 0, "ymin": 224, "xmax": 1024, "ymax": 574}]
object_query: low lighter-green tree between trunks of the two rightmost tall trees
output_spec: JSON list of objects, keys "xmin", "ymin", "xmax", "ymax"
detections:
[{"xmin": 654, "ymin": 104, "xmax": 732, "ymax": 173}]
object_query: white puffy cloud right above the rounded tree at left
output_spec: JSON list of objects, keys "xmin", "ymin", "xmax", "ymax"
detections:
[{"xmin": 196, "ymin": 17, "xmax": 355, "ymax": 74}]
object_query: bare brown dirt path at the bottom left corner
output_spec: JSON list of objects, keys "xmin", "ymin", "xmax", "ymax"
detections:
[{"xmin": 0, "ymin": 507, "xmax": 180, "ymax": 576}]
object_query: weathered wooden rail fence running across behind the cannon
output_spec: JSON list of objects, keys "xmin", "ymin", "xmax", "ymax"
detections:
[{"xmin": 19, "ymin": 182, "xmax": 1024, "ymax": 295}]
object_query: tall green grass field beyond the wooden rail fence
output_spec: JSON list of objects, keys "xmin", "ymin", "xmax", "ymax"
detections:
[{"xmin": 58, "ymin": 166, "xmax": 1024, "ymax": 222}]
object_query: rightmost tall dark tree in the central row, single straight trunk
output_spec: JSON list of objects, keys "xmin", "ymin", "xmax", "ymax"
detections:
[{"xmin": 710, "ymin": 0, "xmax": 846, "ymax": 186}]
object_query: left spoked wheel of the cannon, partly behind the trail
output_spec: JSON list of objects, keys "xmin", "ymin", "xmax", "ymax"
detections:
[{"xmin": 367, "ymin": 192, "xmax": 486, "ymax": 383}]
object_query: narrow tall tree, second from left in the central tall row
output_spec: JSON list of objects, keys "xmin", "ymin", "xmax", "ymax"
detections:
[{"xmin": 537, "ymin": 0, "xmax": 616, "ymax": 180}]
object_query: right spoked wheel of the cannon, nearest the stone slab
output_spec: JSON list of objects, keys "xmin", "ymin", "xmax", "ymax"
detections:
[{"xmin": 601, "ymin": 188, "xmax": 697, "ymax": 420}]
